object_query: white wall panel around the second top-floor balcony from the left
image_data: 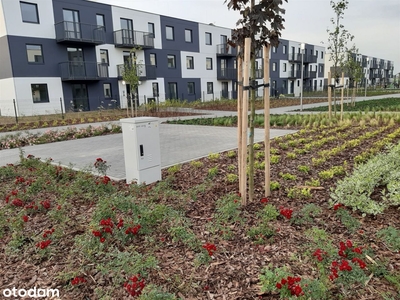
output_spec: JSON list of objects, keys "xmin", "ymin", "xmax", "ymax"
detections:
[{"xmin": 111, "ymin": 6, "xmax": 162, "ymax": 49}]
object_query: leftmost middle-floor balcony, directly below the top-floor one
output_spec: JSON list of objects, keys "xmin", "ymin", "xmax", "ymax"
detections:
[{"xmin": 59, "ymin": 61, "xmax": 108, "ymax": 81}]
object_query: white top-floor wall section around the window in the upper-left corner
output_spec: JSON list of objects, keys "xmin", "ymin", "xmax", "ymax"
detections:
[{"xmin": 0, "ymin": 0, "xmax": 56, "ymax": 38}]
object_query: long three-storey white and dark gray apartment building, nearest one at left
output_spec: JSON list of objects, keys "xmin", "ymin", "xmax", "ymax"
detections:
[{"xmin": 0, "ymin": 0, "xmax": 324, "ymax": 116}]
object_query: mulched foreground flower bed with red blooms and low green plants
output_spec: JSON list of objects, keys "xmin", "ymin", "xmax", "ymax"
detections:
[{"xmin": 0, "ymin": 118, "xmax": 400, "ymax": 300}]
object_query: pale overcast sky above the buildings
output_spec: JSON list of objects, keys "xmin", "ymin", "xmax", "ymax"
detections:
[{"xmin": 92, "ymin": 0, "xmax": 400, "ymax": 74}]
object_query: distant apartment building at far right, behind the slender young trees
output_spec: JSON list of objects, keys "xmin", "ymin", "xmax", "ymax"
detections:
[{"xmin": 325, "ymin": 54, "xmax": 394, "ymax": 87}]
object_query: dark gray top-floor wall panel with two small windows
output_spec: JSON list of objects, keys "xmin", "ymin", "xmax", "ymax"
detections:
[{"xmin": 160, "ymin": 16, "xmax": 200, "ymax": 52}]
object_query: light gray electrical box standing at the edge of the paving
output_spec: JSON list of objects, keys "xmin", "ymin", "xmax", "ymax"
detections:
[{"xmin": 120, "ymin": 117, "xmax": 161, "ymax": 184}]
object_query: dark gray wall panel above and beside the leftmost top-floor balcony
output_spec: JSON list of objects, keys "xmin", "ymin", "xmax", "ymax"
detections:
[{"xmin": 53, "ymin": 0, "xmax": 114, "ymax": 44}]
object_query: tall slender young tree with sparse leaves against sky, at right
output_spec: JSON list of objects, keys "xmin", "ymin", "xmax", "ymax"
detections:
[{"xmin": 327, "ymin": 0, "xmax": 354, "ymax": 114}]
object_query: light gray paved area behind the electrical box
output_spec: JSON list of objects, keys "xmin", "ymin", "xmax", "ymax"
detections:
[{"xmin": 0, "ymin": 124, "xmax": 295, "ymax": 179}]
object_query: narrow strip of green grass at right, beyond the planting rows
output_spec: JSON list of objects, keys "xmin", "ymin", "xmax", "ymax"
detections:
[{"xmin": 304, "ymin": 98, "xmax": 400, "ymax": 111}]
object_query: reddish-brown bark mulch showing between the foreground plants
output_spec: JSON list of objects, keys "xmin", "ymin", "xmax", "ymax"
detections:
[{"xmin": 0, "ymin": 120, "xmax": 400, "ymax": 300}]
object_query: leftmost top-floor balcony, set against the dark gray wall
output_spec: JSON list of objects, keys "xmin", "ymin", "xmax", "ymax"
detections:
[{"xmin": 54, "ymin": 21, "xmax": 106, "ymax": 45}]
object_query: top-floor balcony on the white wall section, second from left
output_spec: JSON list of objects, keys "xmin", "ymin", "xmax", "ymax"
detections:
[{"xmin": 114, "ymin": 29, "xmax": 154, "ymax": 49}]
